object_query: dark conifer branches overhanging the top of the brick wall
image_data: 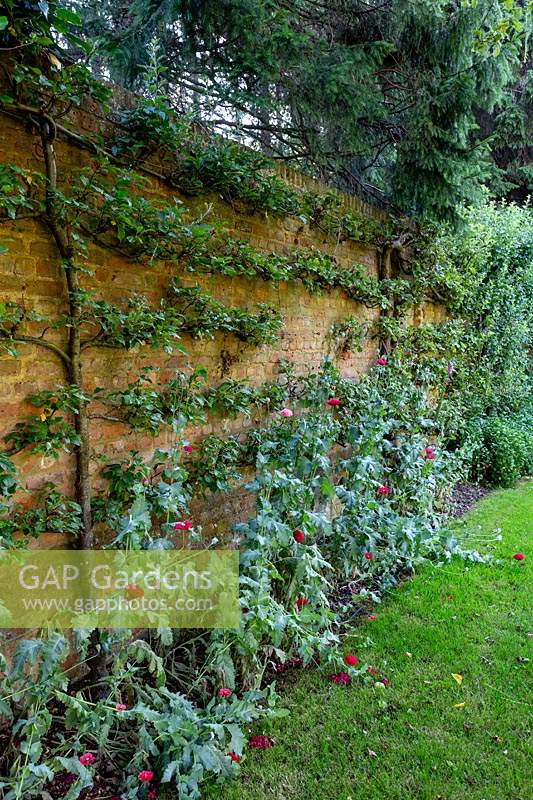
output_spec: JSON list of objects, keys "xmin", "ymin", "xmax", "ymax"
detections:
[{"xmin": 69, "ymin": 0, "xmax": 531, "ymax": 219}]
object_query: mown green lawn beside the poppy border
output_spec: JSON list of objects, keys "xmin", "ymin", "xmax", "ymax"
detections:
[{"xmin": 206, "ymin": 481, "xmax": 533, "ymax": 800}]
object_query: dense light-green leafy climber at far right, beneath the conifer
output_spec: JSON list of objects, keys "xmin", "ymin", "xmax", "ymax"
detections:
[{"xmin": 406, "ymin": 203, "xmax": 533, "ymax": 481}]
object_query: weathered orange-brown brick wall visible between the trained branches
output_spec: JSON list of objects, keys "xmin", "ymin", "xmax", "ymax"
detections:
[{"xmin": 0, "ymin": 103, "xmax": 442, "ymax": 547}]
